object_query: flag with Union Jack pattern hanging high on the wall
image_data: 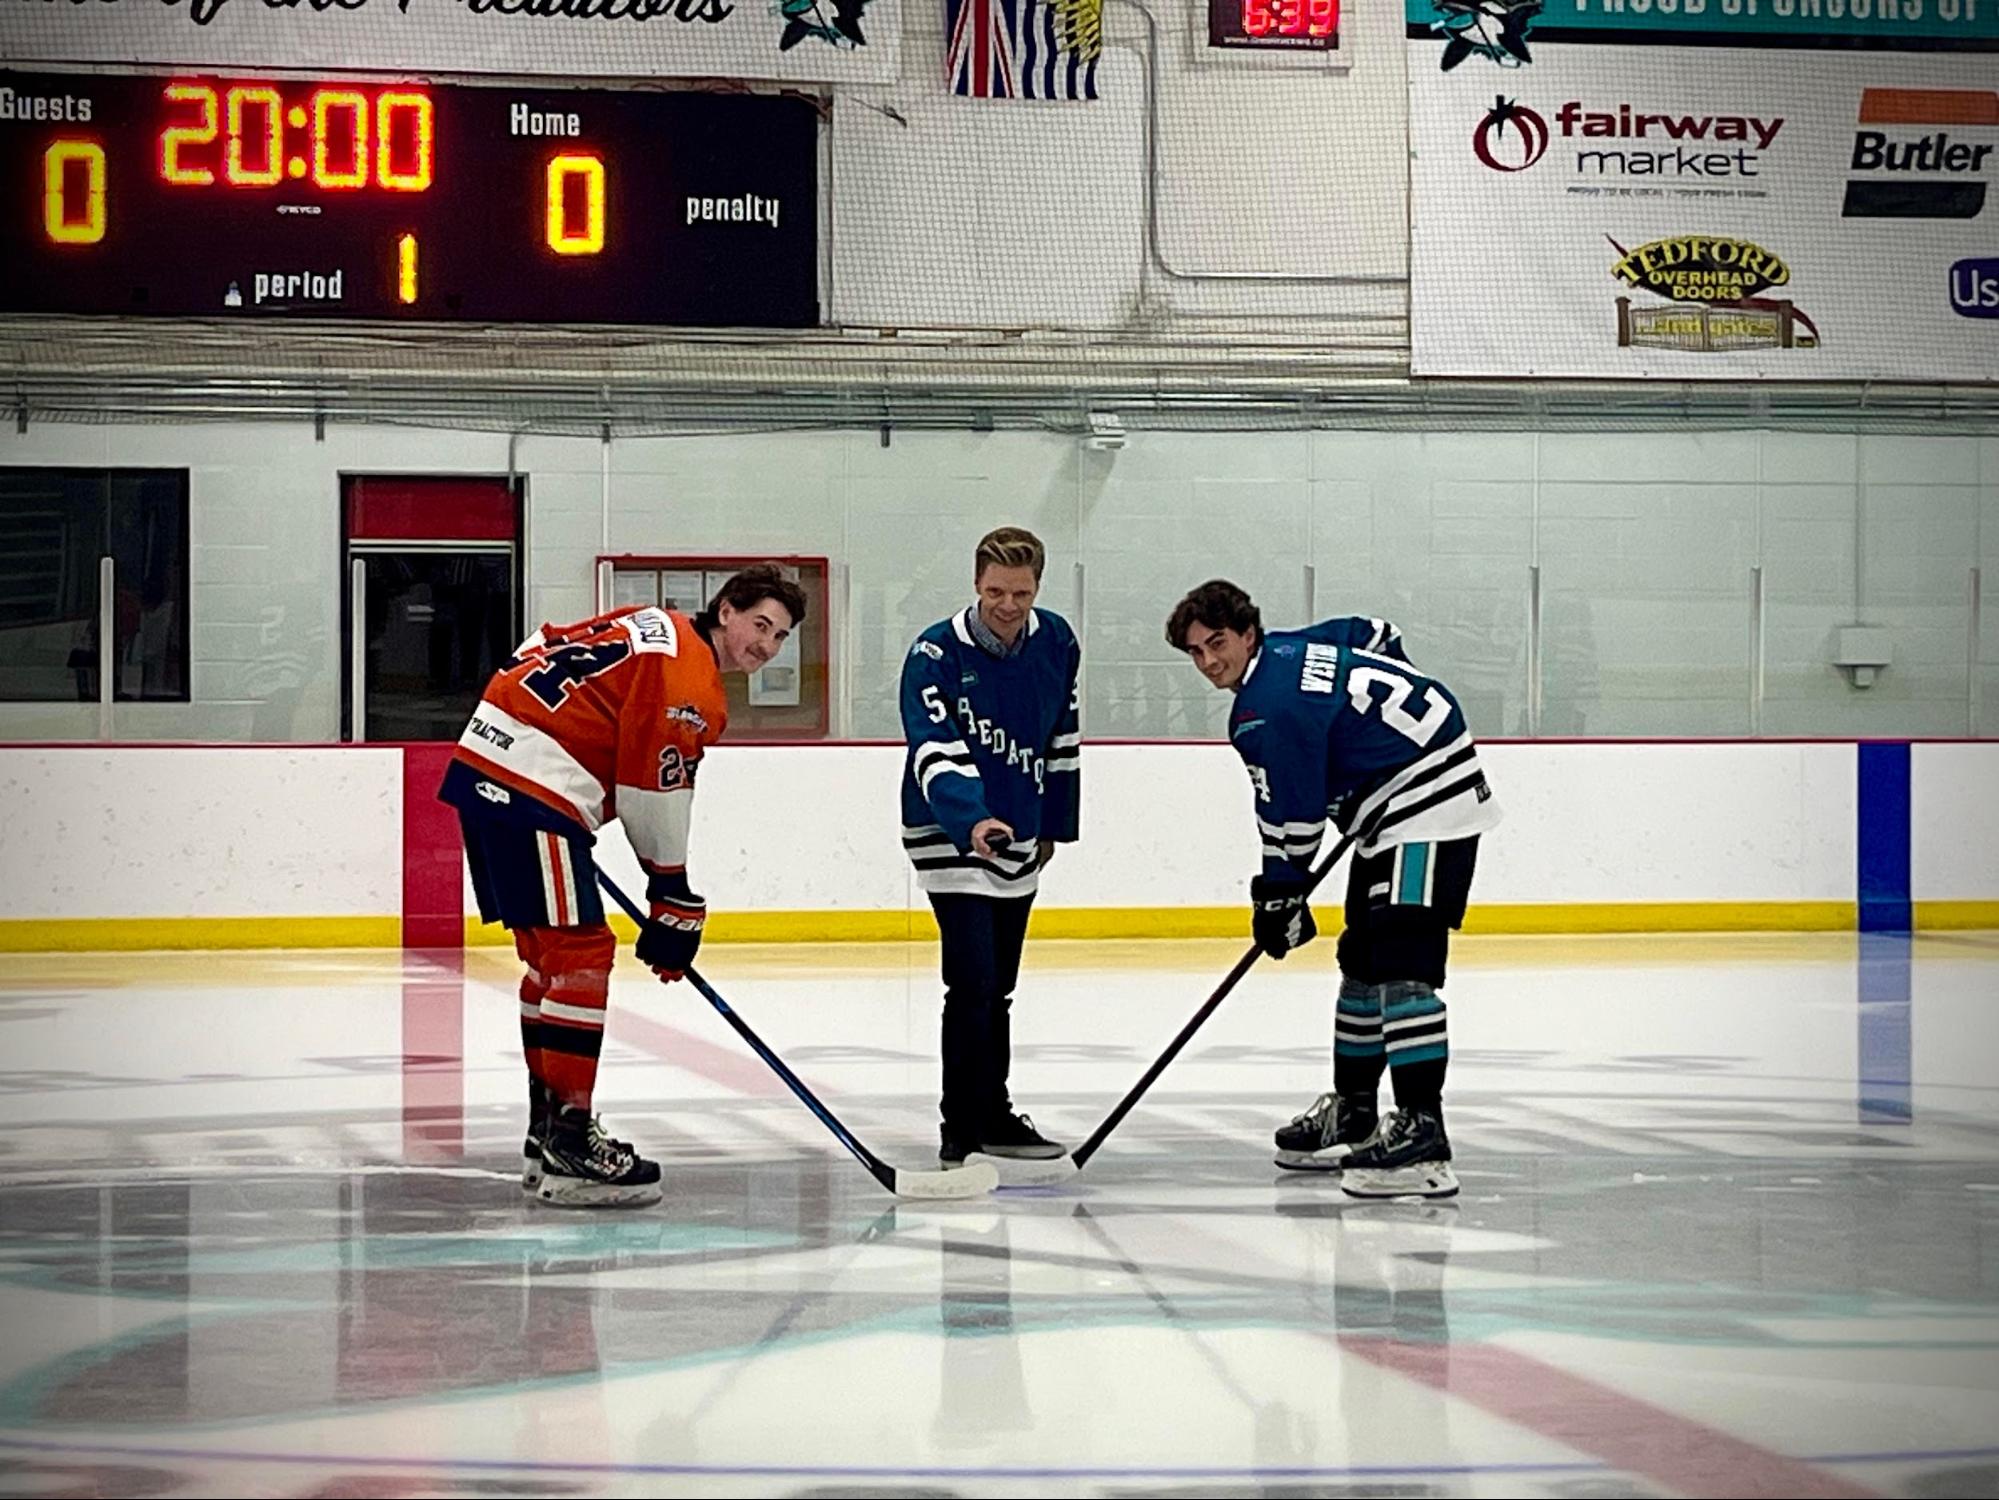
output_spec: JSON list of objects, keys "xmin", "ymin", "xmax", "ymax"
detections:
[{"xmin": 944, "ymin": 0, "xmax": 1103, "ymax": 100}]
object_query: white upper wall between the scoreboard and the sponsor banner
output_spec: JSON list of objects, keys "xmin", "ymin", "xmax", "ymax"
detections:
[{"xmin": 828, "ymin": 0, "xmax": 1407, "ymax": 332}]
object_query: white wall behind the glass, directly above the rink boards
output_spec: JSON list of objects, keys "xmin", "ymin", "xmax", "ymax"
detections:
[{"xmin": 0, "ymin": 424, "xmax": 1999, "ymax": 740}]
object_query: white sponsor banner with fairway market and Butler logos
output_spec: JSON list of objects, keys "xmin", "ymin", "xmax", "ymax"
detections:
[{"xmin": 1407, "ymin": 11, "xmax": 1999, "ymax": 380}]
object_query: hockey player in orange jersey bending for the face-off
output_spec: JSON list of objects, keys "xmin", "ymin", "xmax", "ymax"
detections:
[{"xmin": 440, "ymin": 564, "xmax": 806, "ymax": 1208}]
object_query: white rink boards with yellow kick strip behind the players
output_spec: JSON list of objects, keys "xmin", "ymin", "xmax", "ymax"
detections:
[{"xmin": 0, "ymin": 742, "xmax": 1999, "ymax": 950}]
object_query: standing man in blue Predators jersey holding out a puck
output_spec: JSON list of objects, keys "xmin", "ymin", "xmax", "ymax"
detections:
[{"xmin": 902, "ymin": 526, "xmax": 1081, "ymax": 1166}]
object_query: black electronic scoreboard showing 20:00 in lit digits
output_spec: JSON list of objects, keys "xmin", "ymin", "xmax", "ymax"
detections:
[{"xmin": 0, "ymin": 72, "xmax": 820, "ymax": 328}]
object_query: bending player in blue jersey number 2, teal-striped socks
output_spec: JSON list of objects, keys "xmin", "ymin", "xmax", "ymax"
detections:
[{"xmin": 1165, "ymin": 578, "xmax": 1499, "ymax": 1198}]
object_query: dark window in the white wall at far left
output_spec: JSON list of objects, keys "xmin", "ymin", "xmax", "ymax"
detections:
[{"xmin": 0, "ymin": 468, "xmax": 188, "ymax": 702}]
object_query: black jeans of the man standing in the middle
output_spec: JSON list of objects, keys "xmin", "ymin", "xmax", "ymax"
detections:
[{"xmin": 930, "ymin": 892, "xmax": 1033, "ymax": 1140}]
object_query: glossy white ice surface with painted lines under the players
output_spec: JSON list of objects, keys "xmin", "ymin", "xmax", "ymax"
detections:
[{"xmin": 0, "ymin": 934, "xmax": 1999, "ymax": 1496}]
